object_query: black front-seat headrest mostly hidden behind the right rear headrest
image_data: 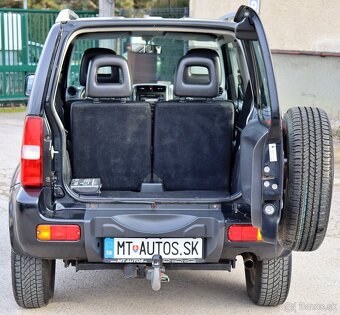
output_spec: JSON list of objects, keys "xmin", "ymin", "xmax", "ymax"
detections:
[{"xmin": 185, "ymin": 48, "xmax": 222, "ymax": 85}]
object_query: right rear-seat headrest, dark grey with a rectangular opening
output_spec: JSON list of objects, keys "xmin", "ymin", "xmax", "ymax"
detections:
[{"xmin": 174, "ymin": 54, "xmax": 219, "ymax": 98}]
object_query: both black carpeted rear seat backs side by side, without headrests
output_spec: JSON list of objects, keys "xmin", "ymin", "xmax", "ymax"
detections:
[{"xmin": 67, "ymin": 98, "xmax": 233, "ymax": 198}]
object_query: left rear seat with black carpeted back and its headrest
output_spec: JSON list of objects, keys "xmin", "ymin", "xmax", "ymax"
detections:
[{"xmin": 71, "ymin": 55, "xmax": 151, "ymax": 191}]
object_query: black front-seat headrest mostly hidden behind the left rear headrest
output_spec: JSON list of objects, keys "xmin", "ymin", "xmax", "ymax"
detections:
[{"xmin": 79, "ymin": 48, "xmax": 119, "ymax": 86}]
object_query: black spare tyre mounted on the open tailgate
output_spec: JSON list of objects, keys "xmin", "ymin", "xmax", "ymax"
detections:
[{"xmin": 279, "ymin": 107, "xmax": 334, "ymax": 251}]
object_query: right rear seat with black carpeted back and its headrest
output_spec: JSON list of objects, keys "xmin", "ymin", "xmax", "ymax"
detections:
[{"xmin": 153, "ymin": 50, "xmax": 234, "ymax": 191}]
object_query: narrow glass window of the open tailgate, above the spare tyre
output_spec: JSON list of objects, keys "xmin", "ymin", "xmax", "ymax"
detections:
[{"xmin": 250, "ymin": 41, "xmax": 271, "ymax": 124}]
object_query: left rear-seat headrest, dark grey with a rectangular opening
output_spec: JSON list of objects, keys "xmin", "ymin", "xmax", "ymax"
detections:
[{"xmin": 85, "ymin": 55, "xmax": 132, "ymax": 98}]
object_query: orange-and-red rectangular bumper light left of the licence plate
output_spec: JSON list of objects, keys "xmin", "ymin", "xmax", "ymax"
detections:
[{"xmin": 37, "ymin": 224, "xmax": 80, "ymax": 241}]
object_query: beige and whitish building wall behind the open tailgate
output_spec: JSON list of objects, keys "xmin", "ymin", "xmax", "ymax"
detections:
[{"xmin": 190, "ymin": 0, "xmax": 340, "ymax": 124}]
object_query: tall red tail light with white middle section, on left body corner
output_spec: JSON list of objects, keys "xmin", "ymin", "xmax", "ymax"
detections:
[{"xmin": 20, "ymin": 116, "xmax": 44, "ymax": 187}]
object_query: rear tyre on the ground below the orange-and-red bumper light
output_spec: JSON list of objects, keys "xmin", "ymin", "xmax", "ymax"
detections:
[{"xmin": 11, "ymin": 251, "xmax": 55, "ymax": 308}]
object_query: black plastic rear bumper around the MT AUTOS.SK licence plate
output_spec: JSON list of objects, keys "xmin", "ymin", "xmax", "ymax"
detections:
[{"xmin": 9, "ymin": 185, "xmax": 288, "ymax": 263}]
